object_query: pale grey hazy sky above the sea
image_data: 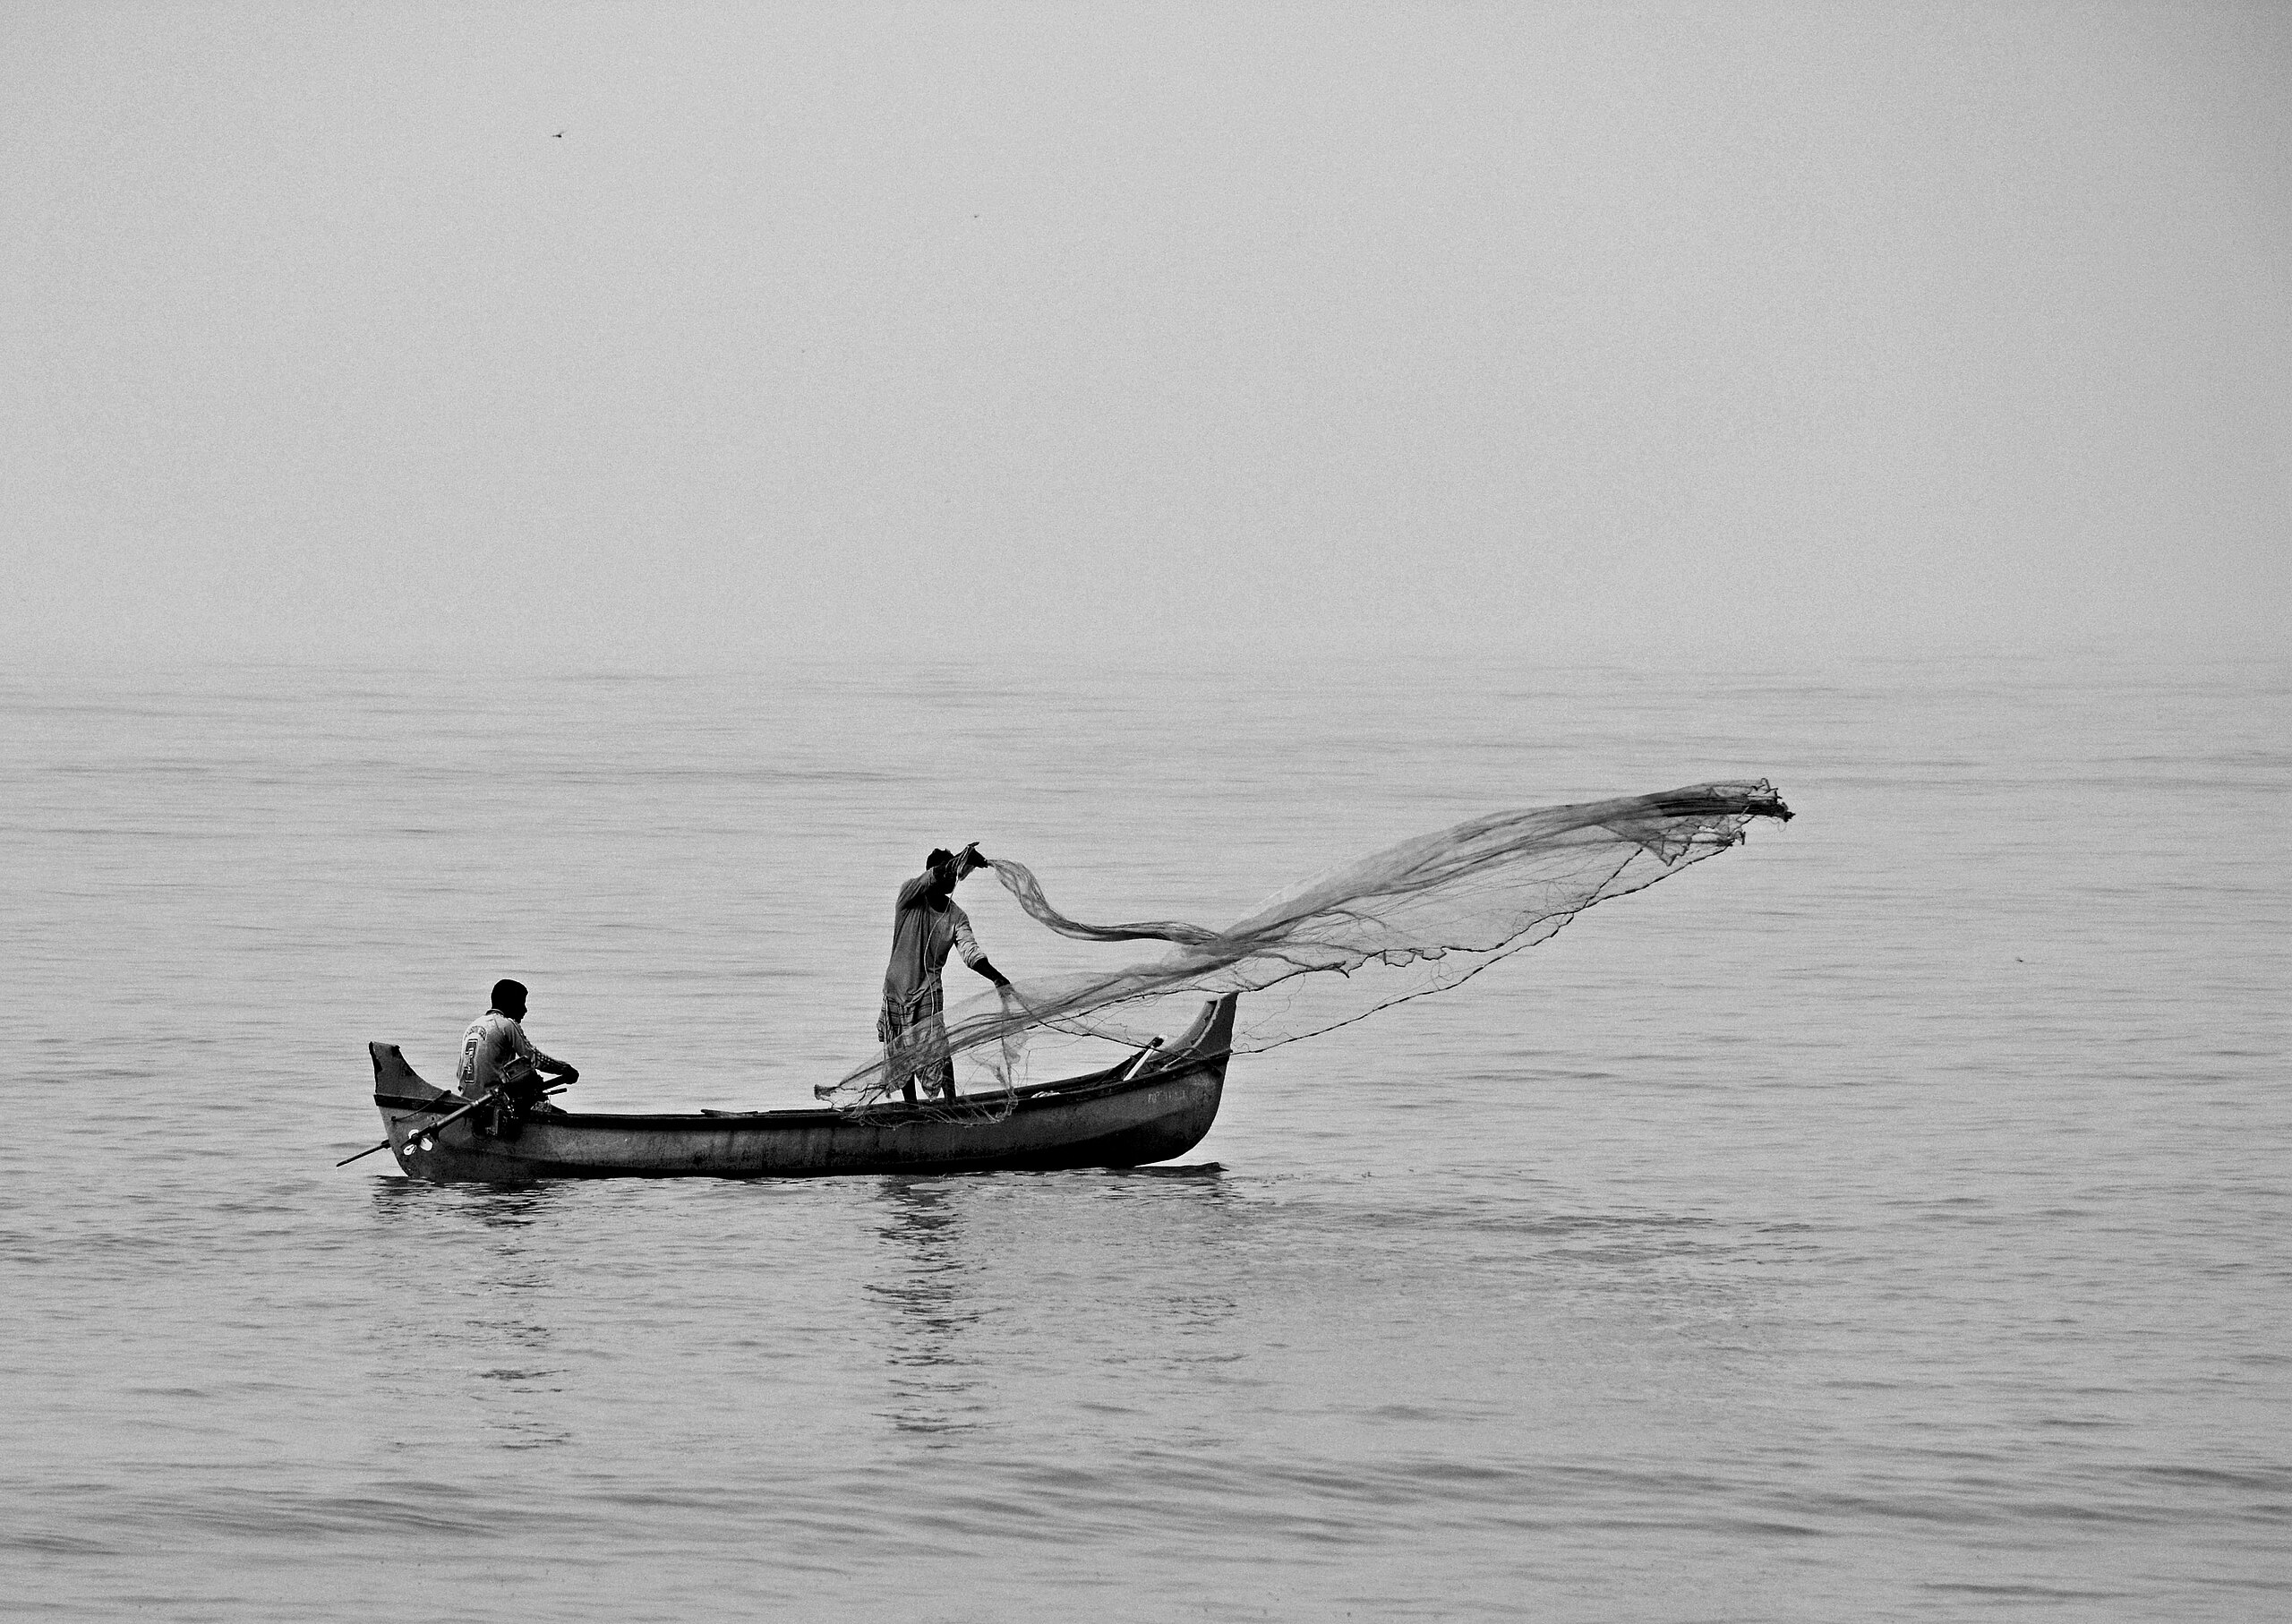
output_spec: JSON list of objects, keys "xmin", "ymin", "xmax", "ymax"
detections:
[{"xmin": 0, "ymin": 0, "xmax": 2292, "ymax": 664}]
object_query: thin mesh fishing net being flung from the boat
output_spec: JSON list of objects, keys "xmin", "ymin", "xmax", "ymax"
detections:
[{"xmin": 814, "ymin": 779, "xmax": 1790, "ymax": 1113}]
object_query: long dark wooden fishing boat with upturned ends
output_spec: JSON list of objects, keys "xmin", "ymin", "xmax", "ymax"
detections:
[{"xmin": 367, "ymin": 994, "xmax": 1237, "ymax": 1184}]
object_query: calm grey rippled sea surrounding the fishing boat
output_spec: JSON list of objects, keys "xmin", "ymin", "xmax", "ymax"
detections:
[{"xmin": 0, "ymin": 662, "xmax": 2292, "ymax": 1621}]
